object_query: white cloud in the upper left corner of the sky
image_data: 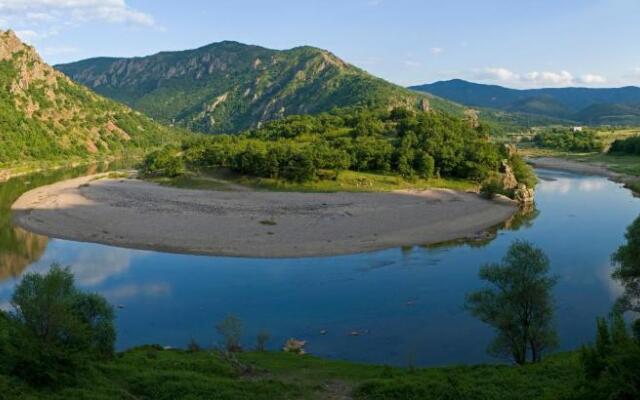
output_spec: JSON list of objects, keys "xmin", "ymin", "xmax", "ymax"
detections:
[{"xmin": 0, "ymin": 0, "xmax": 155, "ymax": 41}]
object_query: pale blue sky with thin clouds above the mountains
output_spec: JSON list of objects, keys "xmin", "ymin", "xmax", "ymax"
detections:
[{"xmin": 0, "ymin": 0, "xmax": 640, "ymax": 88}]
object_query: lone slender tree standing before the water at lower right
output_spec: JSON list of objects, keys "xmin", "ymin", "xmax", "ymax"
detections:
[{"xmin": 466, "ymin": 240, "xmax": 557, "ymax": 364}]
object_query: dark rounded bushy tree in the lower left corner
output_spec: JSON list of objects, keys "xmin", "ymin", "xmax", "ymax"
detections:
[{"xmin": 7, "ymin": 264, "xmax": 116, "ymax": 385}]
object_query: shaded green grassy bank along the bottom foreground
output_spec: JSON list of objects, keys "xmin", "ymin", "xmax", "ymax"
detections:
[{"xmin": 0, "ymin": 346, "xmax": 580, "ymax": 400}]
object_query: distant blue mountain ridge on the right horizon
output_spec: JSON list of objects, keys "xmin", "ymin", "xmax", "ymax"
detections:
[{"xmin": 410, "ymin": 79, "xmax": 640, "ymax": 124}]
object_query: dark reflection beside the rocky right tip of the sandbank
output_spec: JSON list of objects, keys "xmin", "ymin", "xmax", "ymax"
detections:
[{"xmin": 422, "ymin": 203, "xmax": 540, "ymax": 249}]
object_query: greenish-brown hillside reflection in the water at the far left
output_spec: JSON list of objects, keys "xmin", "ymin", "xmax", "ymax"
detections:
[{"xmin": 0, "ymin": 164, "xmax": 122, "ymax": 282}]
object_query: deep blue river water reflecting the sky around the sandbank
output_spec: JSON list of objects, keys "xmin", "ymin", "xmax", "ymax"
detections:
[{"xmin": 0, "ymin": 171, "xmax": 640, "ymax": 365}]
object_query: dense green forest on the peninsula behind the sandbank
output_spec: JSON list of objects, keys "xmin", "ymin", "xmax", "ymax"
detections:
[{"xmin": 142, "ymin": 108, "xmax": 534, "ymax": 195}]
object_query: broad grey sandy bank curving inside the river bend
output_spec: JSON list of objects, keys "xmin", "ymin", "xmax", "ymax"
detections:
[{"xmin": 13, "ymin": 177, "xmax": 517, "ymax": 257}]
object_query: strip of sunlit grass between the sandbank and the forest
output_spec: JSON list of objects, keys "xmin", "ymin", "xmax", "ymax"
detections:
[{"xmin": 153, "ymin": 169, "xmax": 478, "ymax": 192}]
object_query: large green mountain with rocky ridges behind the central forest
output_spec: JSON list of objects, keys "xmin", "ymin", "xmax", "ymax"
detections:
[{"xmin": 56, "ymin": 41, "xmax": 464, "ymax": 133}]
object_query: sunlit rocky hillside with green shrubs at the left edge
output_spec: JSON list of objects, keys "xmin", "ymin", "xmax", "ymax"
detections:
[{"xmin": 0, "ymin": 31, "xmax": 178, "ymax": 164}]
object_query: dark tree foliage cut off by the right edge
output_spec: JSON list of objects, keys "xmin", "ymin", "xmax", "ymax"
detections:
[{"xmin": 611, "ymin": 217, "xmax": 640, "ymax": 311}]
